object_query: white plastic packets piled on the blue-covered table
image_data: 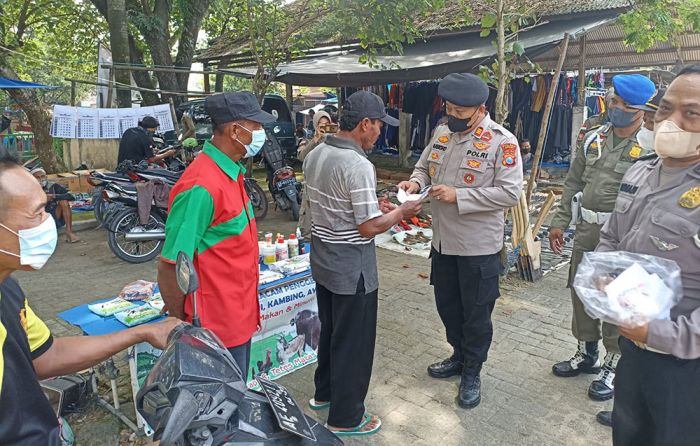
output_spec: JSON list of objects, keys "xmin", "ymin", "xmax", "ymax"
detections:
[{"xmin": 88, "ymin": 280, "xmax": 165, "ymax": 327}]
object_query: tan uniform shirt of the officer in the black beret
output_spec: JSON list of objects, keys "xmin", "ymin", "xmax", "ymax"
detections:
[{"xmin": 411, "ymin": 115, "xmax": 523, "ymax": 256}]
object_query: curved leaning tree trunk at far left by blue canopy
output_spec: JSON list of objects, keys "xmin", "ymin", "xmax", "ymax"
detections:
[{"xmin": 0, "ymin": 66, "xmax": 65, "ymax": 173}]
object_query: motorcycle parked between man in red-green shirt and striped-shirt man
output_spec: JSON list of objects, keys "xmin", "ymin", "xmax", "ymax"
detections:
[{"xmin": 262, "ymin": 129, "xmax": 301, "ymax": 221}]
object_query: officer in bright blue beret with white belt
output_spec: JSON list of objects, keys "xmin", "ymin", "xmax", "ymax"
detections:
[{"xmin": 549, "ymin": 75, "xmax": 655, "ymax": 401}]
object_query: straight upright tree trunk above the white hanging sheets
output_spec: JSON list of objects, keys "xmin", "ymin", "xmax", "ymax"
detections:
[{"xmin": 107, "ymin": 0, "xmax": 131, "ymax": 108}]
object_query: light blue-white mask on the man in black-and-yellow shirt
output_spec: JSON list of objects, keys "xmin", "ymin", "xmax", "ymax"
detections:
[{"xmin": 0, "ymin": 215, "xmax": 58, "ymax": 269}]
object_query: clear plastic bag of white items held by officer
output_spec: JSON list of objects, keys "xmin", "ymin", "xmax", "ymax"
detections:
[{"xmin": 574, "ymin": 251, "xmax": 683, "ymax": 327}]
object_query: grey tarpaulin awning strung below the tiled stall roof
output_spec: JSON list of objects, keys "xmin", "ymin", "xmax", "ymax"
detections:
[{"xmin": 221, "ymin": 11, "xmax": 618, "ymax": 87}]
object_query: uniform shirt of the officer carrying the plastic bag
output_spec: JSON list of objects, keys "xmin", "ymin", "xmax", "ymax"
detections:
[{"xmin": 596, "ymin": 158, "xmax": 700, "ymax": 359}]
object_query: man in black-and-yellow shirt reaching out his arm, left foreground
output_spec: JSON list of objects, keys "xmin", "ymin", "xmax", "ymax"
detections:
[{"xmin": 0, "ymin": 154, "xmax": 180, "ymax": 446}]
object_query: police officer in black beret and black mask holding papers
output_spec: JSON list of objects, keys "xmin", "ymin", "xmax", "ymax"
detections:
[{"xmin": 399, "ymin": 74, "xmax": 523, "ymax": 408}]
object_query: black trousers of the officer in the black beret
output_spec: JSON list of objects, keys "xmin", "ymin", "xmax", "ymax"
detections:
[{"xmin": 430, "ymin": 249, "xmax": 501, "ymax": 365}]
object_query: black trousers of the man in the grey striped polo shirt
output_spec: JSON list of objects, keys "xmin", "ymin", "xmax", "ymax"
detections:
[{"xmin": 314, "ymin": 275, "xmax": 377, "ymax": 427}]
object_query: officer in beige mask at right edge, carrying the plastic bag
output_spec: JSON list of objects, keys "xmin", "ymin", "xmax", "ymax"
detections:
[{"xmin": 596, "ymin": 65, "xmax": 700, "ymax": 446}]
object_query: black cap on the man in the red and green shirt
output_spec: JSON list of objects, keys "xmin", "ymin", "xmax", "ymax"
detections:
[{"xmin": 204, "ymin": 91, "xmax": 277, "ymax": 125}]
